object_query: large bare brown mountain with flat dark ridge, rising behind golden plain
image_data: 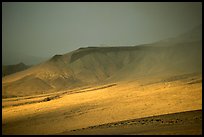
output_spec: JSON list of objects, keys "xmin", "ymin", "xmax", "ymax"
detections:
[{"xmin": 2, "ymin": 26, "xmax": 202, "ymax": 97}]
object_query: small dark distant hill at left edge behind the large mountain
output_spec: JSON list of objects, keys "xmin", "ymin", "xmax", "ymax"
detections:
[{"xmin": 2, "ymin": 63, "xmax": 31, "ymax": 77}]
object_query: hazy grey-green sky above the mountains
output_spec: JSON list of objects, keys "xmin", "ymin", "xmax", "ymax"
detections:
[{"xmin": 2, "ymin": 2, "xmax": 202, "ymax": 64}]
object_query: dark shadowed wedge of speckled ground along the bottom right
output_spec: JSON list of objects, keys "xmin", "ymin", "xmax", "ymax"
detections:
[{"xmin": 60, "ymin": 110, "xmax": 202, "ymax": 135}]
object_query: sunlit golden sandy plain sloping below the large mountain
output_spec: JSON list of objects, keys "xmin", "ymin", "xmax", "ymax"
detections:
[{"xmin": 2, "ymin": 74, "xmax": 202, "ymax": 134}]
